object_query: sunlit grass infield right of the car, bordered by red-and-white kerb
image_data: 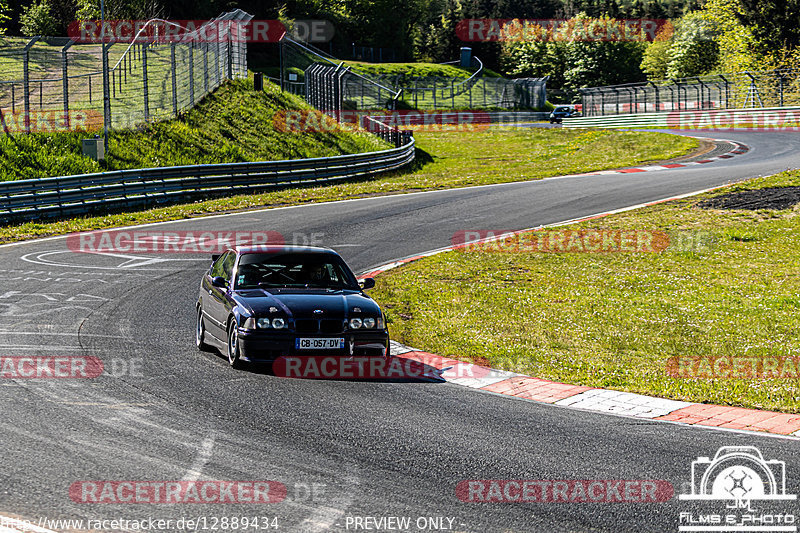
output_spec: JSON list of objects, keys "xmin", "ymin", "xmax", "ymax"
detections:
[{"xmin": 371, "ymin": 171, "xmax": 800, "ymax": 413}]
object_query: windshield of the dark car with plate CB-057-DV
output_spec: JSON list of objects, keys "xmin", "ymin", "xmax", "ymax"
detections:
[{"xmin": 236, "ymin": 253, "xmax": 359, "ymax": 290}]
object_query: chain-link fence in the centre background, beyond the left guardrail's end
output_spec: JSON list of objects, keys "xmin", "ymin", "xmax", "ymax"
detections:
[{"xmin": 278, "ymin": 37, "xmax": 547, "ymax": 110}]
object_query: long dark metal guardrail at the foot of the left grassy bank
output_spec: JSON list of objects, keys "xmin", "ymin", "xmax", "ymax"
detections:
[{"xmin": 0, "ymin": 135, "xmax": 414, "ymax": 224}]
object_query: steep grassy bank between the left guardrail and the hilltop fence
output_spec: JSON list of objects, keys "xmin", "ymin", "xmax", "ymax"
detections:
[{"xmin": 0, "ymin": 80, "xmax": 389, "ymax": 180}]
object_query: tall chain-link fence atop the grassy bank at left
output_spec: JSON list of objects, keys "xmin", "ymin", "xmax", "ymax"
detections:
[{"xmin": 0, "ymin": 10, "xmax": 252, "ymax": 133}]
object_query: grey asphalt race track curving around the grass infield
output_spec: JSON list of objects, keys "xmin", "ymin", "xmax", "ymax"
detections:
[{"xmin": 0, "ymin": 132, "xmax": 800, "ymax": 532}]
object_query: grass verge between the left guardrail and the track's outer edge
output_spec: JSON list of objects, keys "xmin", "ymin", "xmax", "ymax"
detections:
[{"xmin": 0, "ymin": 128, "xmax": 698, "ymax": 242}]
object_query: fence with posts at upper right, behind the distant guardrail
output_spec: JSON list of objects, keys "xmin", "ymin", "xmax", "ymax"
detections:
[{"xmin": 580, "ymin": 69, "xmax": 800, "ymax": 116}]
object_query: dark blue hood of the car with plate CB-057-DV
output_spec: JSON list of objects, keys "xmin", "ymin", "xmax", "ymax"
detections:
[{"xmin": 233, "ymin": 289, "xmax": 379, "ymax": 318}]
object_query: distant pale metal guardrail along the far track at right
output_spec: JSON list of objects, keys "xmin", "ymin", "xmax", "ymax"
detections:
[{"xmin": 563, "ymin": 106, "xmax": 800, "ymax": 131}]
